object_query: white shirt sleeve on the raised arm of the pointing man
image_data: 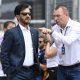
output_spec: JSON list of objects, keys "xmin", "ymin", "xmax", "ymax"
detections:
[{"xmin": 52, "ymin": 27, "xmax": 80, "ymax": 45}]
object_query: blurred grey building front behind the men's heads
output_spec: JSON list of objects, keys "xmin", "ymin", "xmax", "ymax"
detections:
[{"xmin": 0, "ymin": 0, "xmax": 80, "ymax": 31}]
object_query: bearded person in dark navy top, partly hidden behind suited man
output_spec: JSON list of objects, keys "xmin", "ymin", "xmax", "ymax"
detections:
[{"xmin": 36, "ymin": 32, "xmax": 49, "ymax": 80}]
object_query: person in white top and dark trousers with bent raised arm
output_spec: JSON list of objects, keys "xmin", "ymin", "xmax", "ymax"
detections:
[{"xmin": 45, "ymin": 28, "xmax": 59, "ymax": 80}]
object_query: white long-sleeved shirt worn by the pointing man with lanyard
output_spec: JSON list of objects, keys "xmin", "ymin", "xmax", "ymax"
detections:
[{"xmin": 52, "ymin": 19, "xmax": 80, "ymax": 66}]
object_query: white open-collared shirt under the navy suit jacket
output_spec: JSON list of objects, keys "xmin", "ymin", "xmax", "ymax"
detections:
[{"xmin": 19, "ymin": 24, "xmax": 34, "ymax": 66}]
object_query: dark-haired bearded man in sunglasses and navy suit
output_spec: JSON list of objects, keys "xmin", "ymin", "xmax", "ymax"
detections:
[{"xmin": 1, "ymin": 4, "xmax": 38, "ymax": 80}]
